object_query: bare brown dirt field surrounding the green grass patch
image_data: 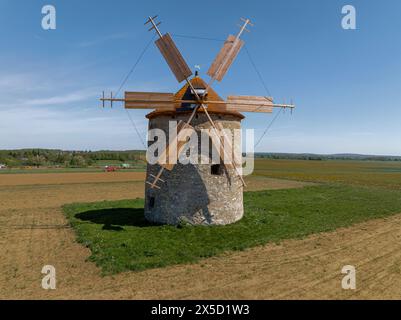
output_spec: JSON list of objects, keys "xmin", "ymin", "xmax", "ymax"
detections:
[{"xmin": 0, "ymin": 173, "xmax": 401, "ymax": 299}]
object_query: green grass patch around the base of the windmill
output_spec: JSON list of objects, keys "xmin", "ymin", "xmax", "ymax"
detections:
[{"xmin": 63, "ymin": 185, "xmax": 401, "ymax": 274}]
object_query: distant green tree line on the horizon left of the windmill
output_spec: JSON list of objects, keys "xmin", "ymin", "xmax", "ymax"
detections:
[{"xmin": 0, "ymin": 149, "xmax": 145, "ymax": 167}]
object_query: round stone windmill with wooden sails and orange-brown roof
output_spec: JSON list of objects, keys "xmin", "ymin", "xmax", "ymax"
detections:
[{"xmin": 101, "ymin": 16, "xmax": 294, "ymax": 225}]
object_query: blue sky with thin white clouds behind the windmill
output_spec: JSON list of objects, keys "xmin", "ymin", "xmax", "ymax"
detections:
[{"xmin": 0, "ymin": 0, "xmax": 401, "ymax": 155}]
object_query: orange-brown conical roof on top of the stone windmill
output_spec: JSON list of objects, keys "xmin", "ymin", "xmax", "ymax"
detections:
[{"xmin": 146, "ymin": 76, "xmax": 245, "ymax": 119}]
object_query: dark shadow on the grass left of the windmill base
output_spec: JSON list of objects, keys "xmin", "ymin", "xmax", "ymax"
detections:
[{"xmin": 75, "ymin": 208, "xmax": 157, "ymax": 231}]
